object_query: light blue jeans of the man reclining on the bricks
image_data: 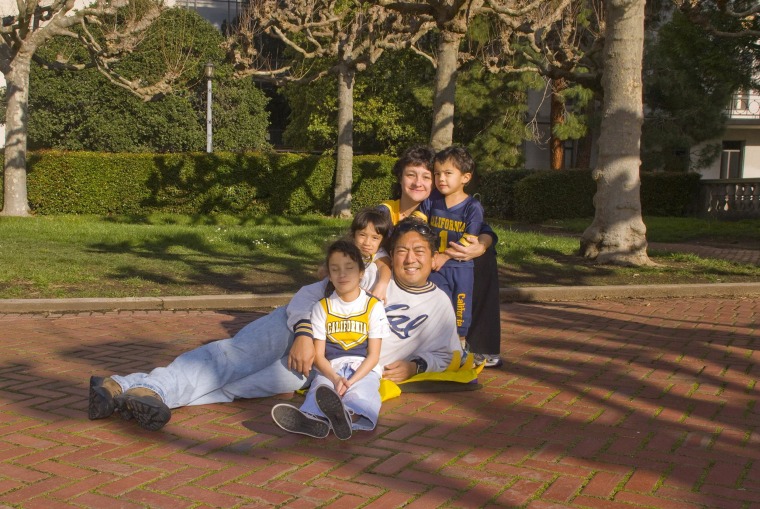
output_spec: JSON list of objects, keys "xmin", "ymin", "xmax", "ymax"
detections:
[{"xmin": 111, "ymin": 307, "xmax": 308, "ymax": 408}]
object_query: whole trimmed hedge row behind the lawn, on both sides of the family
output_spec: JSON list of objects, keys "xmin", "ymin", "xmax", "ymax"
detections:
[{"xmin": 0, "ymin": 151, "xmax": 700, "ymax": 218}]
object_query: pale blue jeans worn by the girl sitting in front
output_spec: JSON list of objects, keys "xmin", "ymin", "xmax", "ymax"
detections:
[{"xmin": 301, "ymin": 364, "xmax": 381, "ymax": 430}]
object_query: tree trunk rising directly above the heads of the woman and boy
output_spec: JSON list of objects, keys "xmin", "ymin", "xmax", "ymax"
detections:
[{"xmin": 430, "ymin": 31, "xmax": 462, "ymax": 150}]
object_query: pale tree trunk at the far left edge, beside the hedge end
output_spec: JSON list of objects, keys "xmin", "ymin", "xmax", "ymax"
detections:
[{"xmin": 0, "ymin": 52, "xmax": 33, "ymax": 216}]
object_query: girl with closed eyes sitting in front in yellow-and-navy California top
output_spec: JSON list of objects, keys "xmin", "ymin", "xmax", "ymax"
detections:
[{"xmin": 272, "ymin": 240, "xmax": 389, "ymax": 440}]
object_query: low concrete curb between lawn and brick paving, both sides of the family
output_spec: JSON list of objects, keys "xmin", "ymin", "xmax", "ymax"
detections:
[{"xmin": 0, "ymin": 283, "xmax": 760, "ymax": 314}]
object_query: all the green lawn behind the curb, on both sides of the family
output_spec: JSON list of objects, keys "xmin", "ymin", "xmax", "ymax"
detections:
[{"xmin": 0, "ymin": 214, "xmax": 760, "ymax": 298}]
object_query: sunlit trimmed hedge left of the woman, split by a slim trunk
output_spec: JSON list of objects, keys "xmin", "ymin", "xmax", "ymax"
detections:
[{"xmin": 0, "ymin": 151, "xmax": 395, "ymax": 215}]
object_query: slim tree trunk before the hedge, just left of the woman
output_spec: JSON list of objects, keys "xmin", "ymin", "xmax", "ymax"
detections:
[{"xmin": 332, "ymin": 64, "xmax": 355, "ymax": 217}]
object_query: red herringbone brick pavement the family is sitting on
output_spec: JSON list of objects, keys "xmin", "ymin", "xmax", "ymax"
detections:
[{"xmin": 0, "ymin": 298, "xmax": 760, "ymax": 509}]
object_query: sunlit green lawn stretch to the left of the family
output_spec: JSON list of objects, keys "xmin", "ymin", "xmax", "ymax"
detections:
[{"xmin": 0, "ymin": 215, "xmax": 345, "ymax": 298}]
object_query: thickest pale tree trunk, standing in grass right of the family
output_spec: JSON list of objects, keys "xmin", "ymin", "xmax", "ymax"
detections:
[{"xmin": 580, "ymin": 0, "xmax": 651, "ymax": 265}]
